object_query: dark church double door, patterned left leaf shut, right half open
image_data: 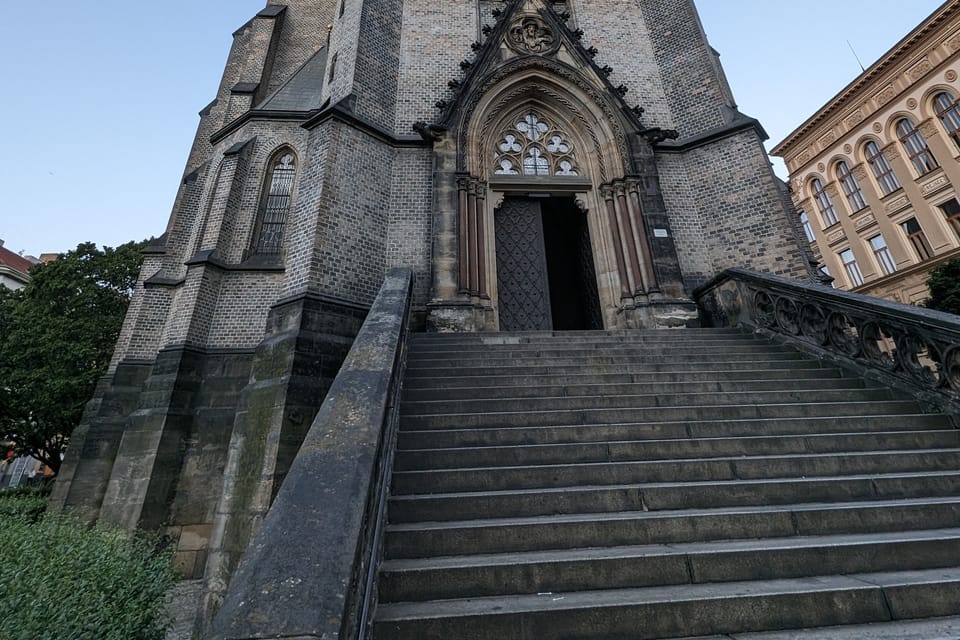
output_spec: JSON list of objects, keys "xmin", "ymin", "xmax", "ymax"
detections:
[{"xmin": 494, "ymin": 197, "xmax": 603, "ymax": 331}]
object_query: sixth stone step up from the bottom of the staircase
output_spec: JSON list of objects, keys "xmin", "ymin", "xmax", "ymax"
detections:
[{"xmin": 394, "ymin": 430, "xmax": 960, "ymax": 471}]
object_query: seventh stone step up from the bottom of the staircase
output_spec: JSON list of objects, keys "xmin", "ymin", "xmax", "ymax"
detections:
[{"xmin": 399, "ymin": 414, "xmax": 954, "ymax": 449}]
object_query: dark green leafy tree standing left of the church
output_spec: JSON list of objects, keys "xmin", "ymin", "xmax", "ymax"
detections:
[{"xmin": 0, "ymin": 241, "xmax": 146, "ymax": 473}]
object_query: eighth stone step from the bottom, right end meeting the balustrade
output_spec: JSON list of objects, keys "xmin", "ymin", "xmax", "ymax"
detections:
[{"xmin": 400, "ymin": 400, "xmax": 918, "ymax": 430}]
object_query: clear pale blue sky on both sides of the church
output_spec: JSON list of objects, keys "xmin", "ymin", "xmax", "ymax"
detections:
[{"xmin": 0, "ymin": 0, "xmax": 941, "ymax": 255}]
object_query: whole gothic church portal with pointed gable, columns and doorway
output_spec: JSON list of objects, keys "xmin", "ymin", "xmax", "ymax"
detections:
[{"xmin": 429, "ymin": 8, "xmax": 682, "ymax": 331}]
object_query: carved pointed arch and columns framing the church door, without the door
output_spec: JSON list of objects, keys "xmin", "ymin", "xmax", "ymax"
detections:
[{"xmin": 438, "ymin": 66, "xmax": 659, "ymax": 328}]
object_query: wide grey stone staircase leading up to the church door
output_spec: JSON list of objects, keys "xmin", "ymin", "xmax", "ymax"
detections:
[{"xmin": 374, "ymin": 329, "xmax": 960, "ymax": 640}]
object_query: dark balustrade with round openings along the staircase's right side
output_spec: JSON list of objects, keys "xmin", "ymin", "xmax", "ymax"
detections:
[{"xmin": 694, "ymin": 269, "xmax": 960, "ymax": 414}]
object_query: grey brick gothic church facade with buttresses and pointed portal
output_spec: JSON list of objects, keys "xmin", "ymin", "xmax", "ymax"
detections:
[{"xmin": 53, "ymin": 0, "xmax": 811, "ymax": 632}]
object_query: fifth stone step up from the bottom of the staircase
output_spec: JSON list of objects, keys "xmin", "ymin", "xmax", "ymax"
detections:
[{"xmin": 393, "ymin": 449, "xmax": 960, "ymax": 495}]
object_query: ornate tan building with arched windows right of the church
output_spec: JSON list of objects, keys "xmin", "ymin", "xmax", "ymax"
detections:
[{"xmin": 773, "ymin": 0, "xmax": 960, "ymax": 303}]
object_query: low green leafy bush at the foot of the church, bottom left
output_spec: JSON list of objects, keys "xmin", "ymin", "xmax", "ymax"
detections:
[{"xmin": 0, "ymin": 492, "xmax": 174, "ymax": 640}]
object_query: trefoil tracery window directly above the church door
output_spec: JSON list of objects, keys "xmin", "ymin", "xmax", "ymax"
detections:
[{"xmin": 493, "ymin": 111, "xmax": 580, "ymax": 176}]
